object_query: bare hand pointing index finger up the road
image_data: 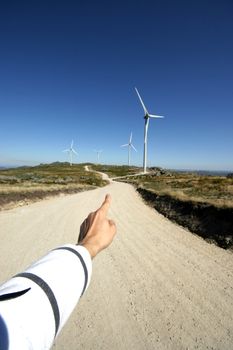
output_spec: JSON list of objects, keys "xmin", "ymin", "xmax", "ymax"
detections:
[{"xmin": 78, "ymin": 194, "xmax": 116, "ymax": 258}]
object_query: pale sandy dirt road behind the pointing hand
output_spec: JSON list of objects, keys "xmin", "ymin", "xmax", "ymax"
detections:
[{"xmin": 0, "ymin": 182, "xmax": 233, "ymax": 350}]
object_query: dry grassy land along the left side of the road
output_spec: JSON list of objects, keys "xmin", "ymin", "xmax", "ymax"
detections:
[{"xmin": 0, "ymin": 162, "xmax": 107, "ymax": 210}]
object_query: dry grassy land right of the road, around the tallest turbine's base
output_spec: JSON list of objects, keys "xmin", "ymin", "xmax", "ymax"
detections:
[{"xmin": 91, "ymin": 165, "xmax": 233, "ymax": 208}]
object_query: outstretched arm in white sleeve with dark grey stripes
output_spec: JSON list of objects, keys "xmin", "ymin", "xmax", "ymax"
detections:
[{"xmin": 0, "ymin": 245, "xmax": 92, "ymax": 349}]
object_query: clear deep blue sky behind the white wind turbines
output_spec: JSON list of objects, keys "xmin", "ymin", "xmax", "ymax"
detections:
[{"xmin": 0, "ymin": 0, "xmax": 233, "ymax": 170}]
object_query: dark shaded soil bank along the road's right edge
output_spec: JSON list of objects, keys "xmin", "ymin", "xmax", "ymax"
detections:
[{"xmin": 137, "ymin": 187, "xmax": 233, "ymax": 249}]
